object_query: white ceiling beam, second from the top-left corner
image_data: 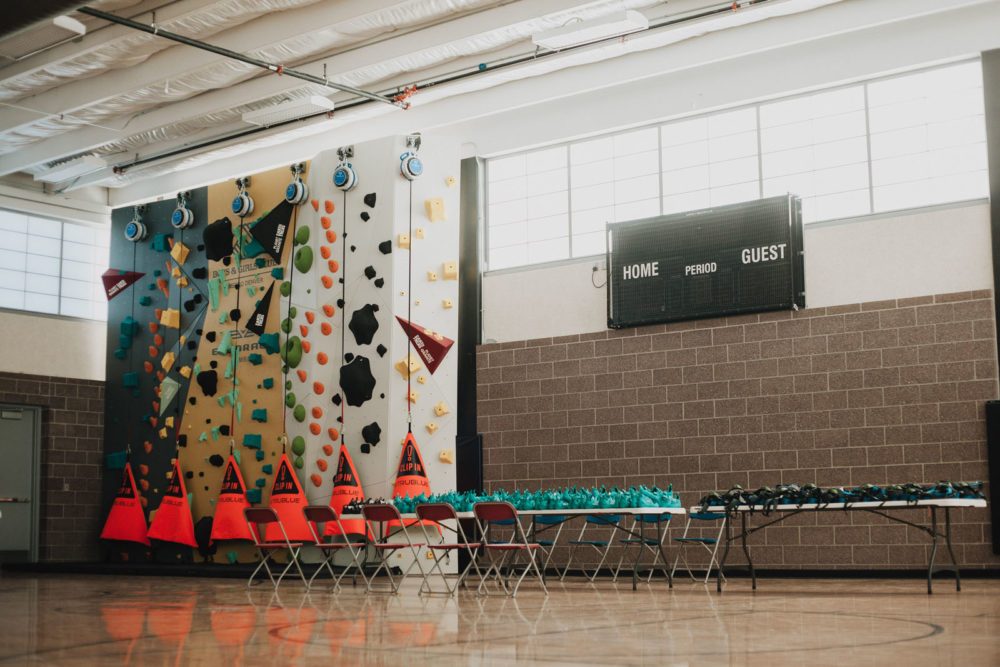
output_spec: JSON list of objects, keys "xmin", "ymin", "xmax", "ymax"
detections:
[{"xmin": 0, "ymin": 0, "xmax": 414, "ymax": 137}]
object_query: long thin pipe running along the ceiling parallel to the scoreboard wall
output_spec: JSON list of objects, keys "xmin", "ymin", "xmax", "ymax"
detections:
[{"xmin": 103, "ymin": 0, "xmax": 769, "ymax": 174}]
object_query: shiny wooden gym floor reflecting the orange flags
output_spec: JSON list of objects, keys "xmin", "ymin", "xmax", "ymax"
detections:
[{"xmin": 0, "ymin": 572, "xmax": 1000, "ymax": 667}]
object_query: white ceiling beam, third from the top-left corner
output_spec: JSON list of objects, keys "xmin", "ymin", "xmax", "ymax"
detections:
[{"xmin": 0, "ymin": 0, "xmax": 616, "ymax": 175}]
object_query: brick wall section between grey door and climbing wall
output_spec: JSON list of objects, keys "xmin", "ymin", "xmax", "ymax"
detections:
[{"xmin": 0, "ymin": 373, "xmax": 104, "ymax": 561}]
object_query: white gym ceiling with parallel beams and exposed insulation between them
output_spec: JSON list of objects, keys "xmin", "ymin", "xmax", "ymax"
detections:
[{"xmin": 0, "ymin": 0, "xmax": 996, "ymax": 205}]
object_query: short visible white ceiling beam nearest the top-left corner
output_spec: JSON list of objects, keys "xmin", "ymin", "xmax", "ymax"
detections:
[{"xmin": 0, "ymin": 0, "xmax": 221, "ymax": 88}]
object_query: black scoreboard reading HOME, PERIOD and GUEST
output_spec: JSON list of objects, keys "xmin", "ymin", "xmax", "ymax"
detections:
[{"xmin": 606, "ymin": 195, "xmax": 806, "ymax": 329}]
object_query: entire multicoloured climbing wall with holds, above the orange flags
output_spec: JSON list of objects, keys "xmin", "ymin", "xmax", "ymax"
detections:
[{"xmin": 106, "ymin": 137, "xmax": 459, "ymax": 562}]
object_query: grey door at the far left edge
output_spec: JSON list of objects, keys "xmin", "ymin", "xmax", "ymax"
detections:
[{"xmin": 0, "ymin": 404, "xmax": 41, "ymax": 563}]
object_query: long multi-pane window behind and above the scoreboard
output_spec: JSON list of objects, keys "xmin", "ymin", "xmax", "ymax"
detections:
[{"xmin": 486, "ymin": 60, "xmax": 989, "ymax": 270}]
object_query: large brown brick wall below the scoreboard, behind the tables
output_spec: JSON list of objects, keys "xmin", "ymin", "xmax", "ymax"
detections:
[{"xmin": 477, "ymin": 291, "xmax": 1000, "ymax": 569}]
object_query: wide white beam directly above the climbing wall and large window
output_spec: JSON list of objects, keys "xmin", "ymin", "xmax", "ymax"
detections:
[{"xmin": 103, "ymin": 0, "xmax": 1000, "ymax": 206}]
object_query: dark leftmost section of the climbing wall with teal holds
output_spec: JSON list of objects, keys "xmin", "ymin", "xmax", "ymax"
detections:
[{"xmin": 101, "ymin": 188, "xmax": 210, "ymax": 551}]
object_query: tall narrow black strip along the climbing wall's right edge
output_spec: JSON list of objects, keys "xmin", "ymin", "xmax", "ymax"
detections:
[{"xmin": 455, "ymin": 158, "xmax": 483, "ymax": 491}]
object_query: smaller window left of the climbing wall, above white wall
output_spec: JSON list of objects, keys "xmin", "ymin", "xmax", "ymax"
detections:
[{"xmin": 0, "ymin": 209, "xmax": 108, "ymax": 320}]
